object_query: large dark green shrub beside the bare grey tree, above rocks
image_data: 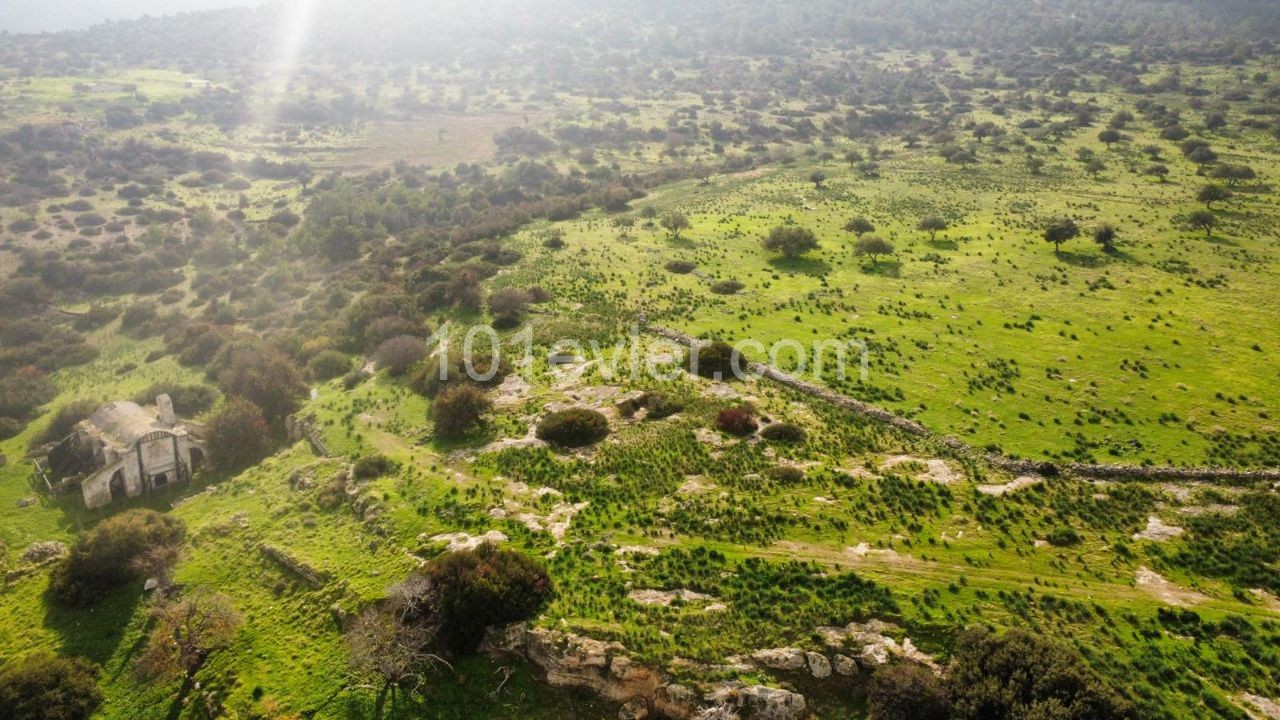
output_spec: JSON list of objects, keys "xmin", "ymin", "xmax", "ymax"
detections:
[{"xmin": 422, "ymin": 543, "xmax": 552, "ymax": 655}]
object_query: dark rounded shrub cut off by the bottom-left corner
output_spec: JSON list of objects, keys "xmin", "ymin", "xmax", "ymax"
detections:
[{"xmin": 0, "ymin": 652, "xmax": 102, "ymax": 720}]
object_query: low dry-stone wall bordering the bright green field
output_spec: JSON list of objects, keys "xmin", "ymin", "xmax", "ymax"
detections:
[{"xmin": 645, "ymin": 325, "xmax": 1280, "ymax": 482}]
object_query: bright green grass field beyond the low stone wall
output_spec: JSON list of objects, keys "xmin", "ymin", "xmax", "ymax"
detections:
[{"xmin": 511, "ymin": 114, "xmax": 1280, "ymax": 465}]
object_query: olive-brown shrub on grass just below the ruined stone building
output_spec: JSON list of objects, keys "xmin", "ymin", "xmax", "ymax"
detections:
[{"xmin": 49, "ymin": 510, "xmax": 186, "ymax": 606}]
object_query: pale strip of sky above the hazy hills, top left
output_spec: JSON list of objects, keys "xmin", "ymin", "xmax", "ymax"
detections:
[{"xmin": 0, "ymin": 0, "xmax": 266, "ymax": 33}]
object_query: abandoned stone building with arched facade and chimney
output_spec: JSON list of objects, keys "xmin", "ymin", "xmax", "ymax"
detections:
[{"xmin": 37, "ymin": 395, "xmax": 205, "ymax": 507}]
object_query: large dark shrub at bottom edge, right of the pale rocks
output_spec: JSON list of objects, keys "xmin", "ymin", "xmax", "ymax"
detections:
[{"xmin": 946, "ymin": 630, "xmax": 1137, "ymax": 720}]
